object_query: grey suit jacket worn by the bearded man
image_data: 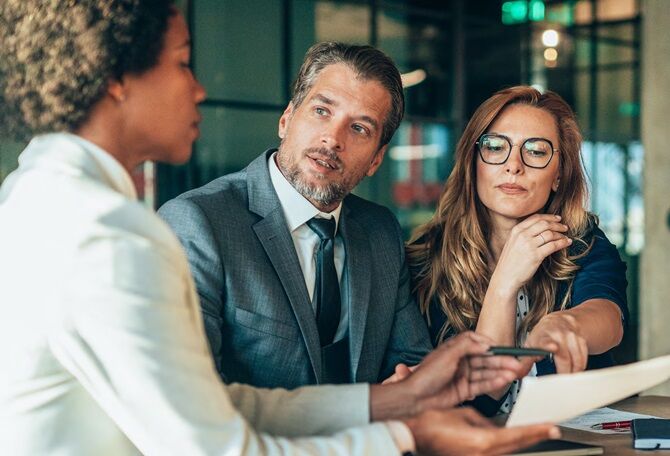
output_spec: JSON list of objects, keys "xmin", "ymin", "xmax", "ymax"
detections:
[{"xmin": 159, "ymin": 150, "xmax": 431, "ymax": 388}]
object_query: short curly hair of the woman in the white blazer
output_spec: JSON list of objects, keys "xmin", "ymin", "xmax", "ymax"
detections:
[{"xmin": 0, "ymin": 0, "xmax": 176, "ymax": 140}]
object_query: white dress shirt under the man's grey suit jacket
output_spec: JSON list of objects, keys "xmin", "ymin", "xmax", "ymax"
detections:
[{"xmin": 268, "ymin": 152, "xmax": 349, "ymax": 341}]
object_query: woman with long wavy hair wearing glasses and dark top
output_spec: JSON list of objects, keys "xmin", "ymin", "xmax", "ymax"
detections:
[{"xmin": 408, "ymin": 87, "xmax": 627, "ymax": 413}]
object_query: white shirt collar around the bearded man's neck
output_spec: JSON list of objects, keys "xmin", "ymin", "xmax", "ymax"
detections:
[{"xmin": 268, "ymin": 152, "xmax": 342, "ymax": 233}]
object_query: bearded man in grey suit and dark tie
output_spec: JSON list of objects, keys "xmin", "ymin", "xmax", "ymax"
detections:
[{"xmin": 159, "ymin": 43, "xmax": 431, "ymax": 388}]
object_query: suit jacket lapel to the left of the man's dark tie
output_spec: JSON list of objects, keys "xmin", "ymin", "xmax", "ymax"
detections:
[{"xmin": 247, "ymin": 150, "xmax": 322, "ymax": 381}]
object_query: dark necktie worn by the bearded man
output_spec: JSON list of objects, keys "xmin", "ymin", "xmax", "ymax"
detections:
[{"xmin": 307, "ymin": 218, "xmax": 341, "ymax": 347}]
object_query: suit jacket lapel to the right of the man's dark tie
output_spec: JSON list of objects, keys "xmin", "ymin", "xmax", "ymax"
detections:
[{"xmin": 340, "ymin": 205, "xmax": 372, "ymax": 379}]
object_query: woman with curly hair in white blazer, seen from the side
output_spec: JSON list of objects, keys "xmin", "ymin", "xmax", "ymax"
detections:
[{"xmin": 0, "ymin": 0, "xmax": 557, "ymax": 456}]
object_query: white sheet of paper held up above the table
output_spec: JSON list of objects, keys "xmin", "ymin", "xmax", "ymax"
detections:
[{"xmin": 507, "ymin": 355, "xmax": 670, "ymax": 427}]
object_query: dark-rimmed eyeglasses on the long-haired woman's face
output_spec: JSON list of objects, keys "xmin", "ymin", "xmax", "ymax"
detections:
[{"xmin": 475, "ymin": 133, "xmax": 558, "ymax": 169}]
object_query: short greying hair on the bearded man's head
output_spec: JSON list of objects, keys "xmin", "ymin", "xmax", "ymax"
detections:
[{"xmin": 291, "ymin": 42, "xmax": 405, "ymax": 147}]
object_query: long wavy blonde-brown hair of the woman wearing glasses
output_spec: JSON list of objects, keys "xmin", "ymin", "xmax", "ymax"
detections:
[{"xmin": 407, "ymin": 86, "xmax": 597, "ymax": 339}]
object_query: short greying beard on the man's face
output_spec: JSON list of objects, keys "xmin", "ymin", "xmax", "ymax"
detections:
[{"xmin": 277, "ymin": 145, "xmax": 364, "ymax": 207}]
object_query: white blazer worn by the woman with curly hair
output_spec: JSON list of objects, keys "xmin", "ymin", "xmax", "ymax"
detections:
[{"xmin": 0, "ymin": 133, "xmax": 398, "ymax": 456}]
